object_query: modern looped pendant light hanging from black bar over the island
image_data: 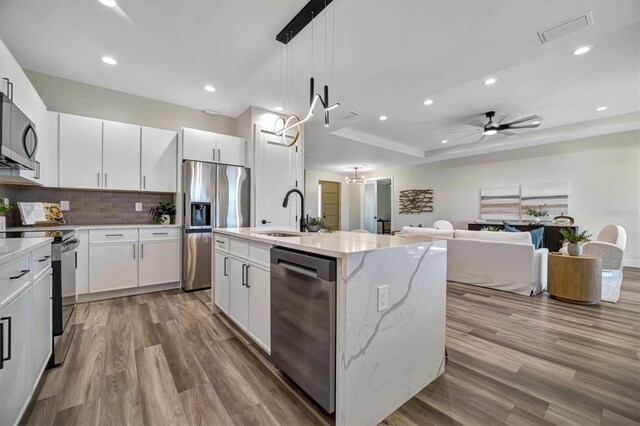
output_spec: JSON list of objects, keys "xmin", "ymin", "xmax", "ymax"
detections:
[{"xmin": 273, "ymin": 0, "xmax": 340, "ymax": 146}]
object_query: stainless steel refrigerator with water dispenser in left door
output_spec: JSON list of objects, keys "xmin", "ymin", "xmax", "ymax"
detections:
[{"xmin": 182, "ymin": 161, "xmax": 251, "ymax": 291}]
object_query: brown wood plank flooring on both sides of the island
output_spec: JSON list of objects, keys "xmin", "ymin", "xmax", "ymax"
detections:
[{"xmin": 26, "ymin": 269, "xmax": 640, "ymax": 425}]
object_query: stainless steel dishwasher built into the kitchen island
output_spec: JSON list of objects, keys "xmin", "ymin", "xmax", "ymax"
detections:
[{"xmin": 271, "ymin": 247, "xmax": 336, "ymax": 413}]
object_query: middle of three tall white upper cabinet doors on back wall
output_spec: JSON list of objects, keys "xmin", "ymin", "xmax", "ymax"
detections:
[{"xmin": 102, "ymin": 121, "xmax": 140, "ymax": 191}]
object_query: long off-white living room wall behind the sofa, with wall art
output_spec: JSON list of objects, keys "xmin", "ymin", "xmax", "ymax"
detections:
[{"xmin": 367, "ymin": 131, "xmax": 640, "ymax": 267}]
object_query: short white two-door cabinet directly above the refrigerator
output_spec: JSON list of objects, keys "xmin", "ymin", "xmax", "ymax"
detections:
[{"xmin": 182, "ymin": 128, "xmax": 245, "ymax": 166}]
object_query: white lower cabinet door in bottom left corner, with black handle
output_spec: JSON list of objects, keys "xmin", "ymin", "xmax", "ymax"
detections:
[{"xmin": 0, "ymin": 290, "xmax": 31, "ymax": 425}]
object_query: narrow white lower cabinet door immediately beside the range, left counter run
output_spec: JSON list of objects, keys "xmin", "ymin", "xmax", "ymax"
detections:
[{"xmin": 31, "ymin": 270, "xmax": 53, "ymax": 391}]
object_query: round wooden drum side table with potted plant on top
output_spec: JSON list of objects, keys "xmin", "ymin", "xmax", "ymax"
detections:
[{"xmin": 547, "ymin": 254, "xmax": 602, "ymax": 305}]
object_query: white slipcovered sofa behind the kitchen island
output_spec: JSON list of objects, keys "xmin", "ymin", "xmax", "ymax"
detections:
[{"xmin": 402, "ymin": 227, "xmax": 549, "ymax": 296}]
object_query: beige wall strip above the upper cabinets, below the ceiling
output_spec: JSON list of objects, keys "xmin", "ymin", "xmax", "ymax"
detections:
[{"xmin": 25, "ymin": 70, "xmax": 238, "ymax": 136}]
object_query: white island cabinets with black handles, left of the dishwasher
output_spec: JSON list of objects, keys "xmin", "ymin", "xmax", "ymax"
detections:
[{"xmin": 213, "ymin": 236, "xmax": 271, "ymax": 352}]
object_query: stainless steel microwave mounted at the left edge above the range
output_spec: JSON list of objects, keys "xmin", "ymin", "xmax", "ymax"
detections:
[{"xmin": 0, "ymin": 93, "xmax": 38, "ymax": 170}]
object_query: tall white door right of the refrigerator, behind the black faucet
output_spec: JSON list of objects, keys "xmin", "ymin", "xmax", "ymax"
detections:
[{"xmin": 255, "ymin": 130, "xmax": 304, "ymax": 227}]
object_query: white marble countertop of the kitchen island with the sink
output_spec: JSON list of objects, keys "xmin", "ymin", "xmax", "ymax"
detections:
[{"xmin": 214, "ymin": 227, "xmax": 438, "ymax": 257}]
